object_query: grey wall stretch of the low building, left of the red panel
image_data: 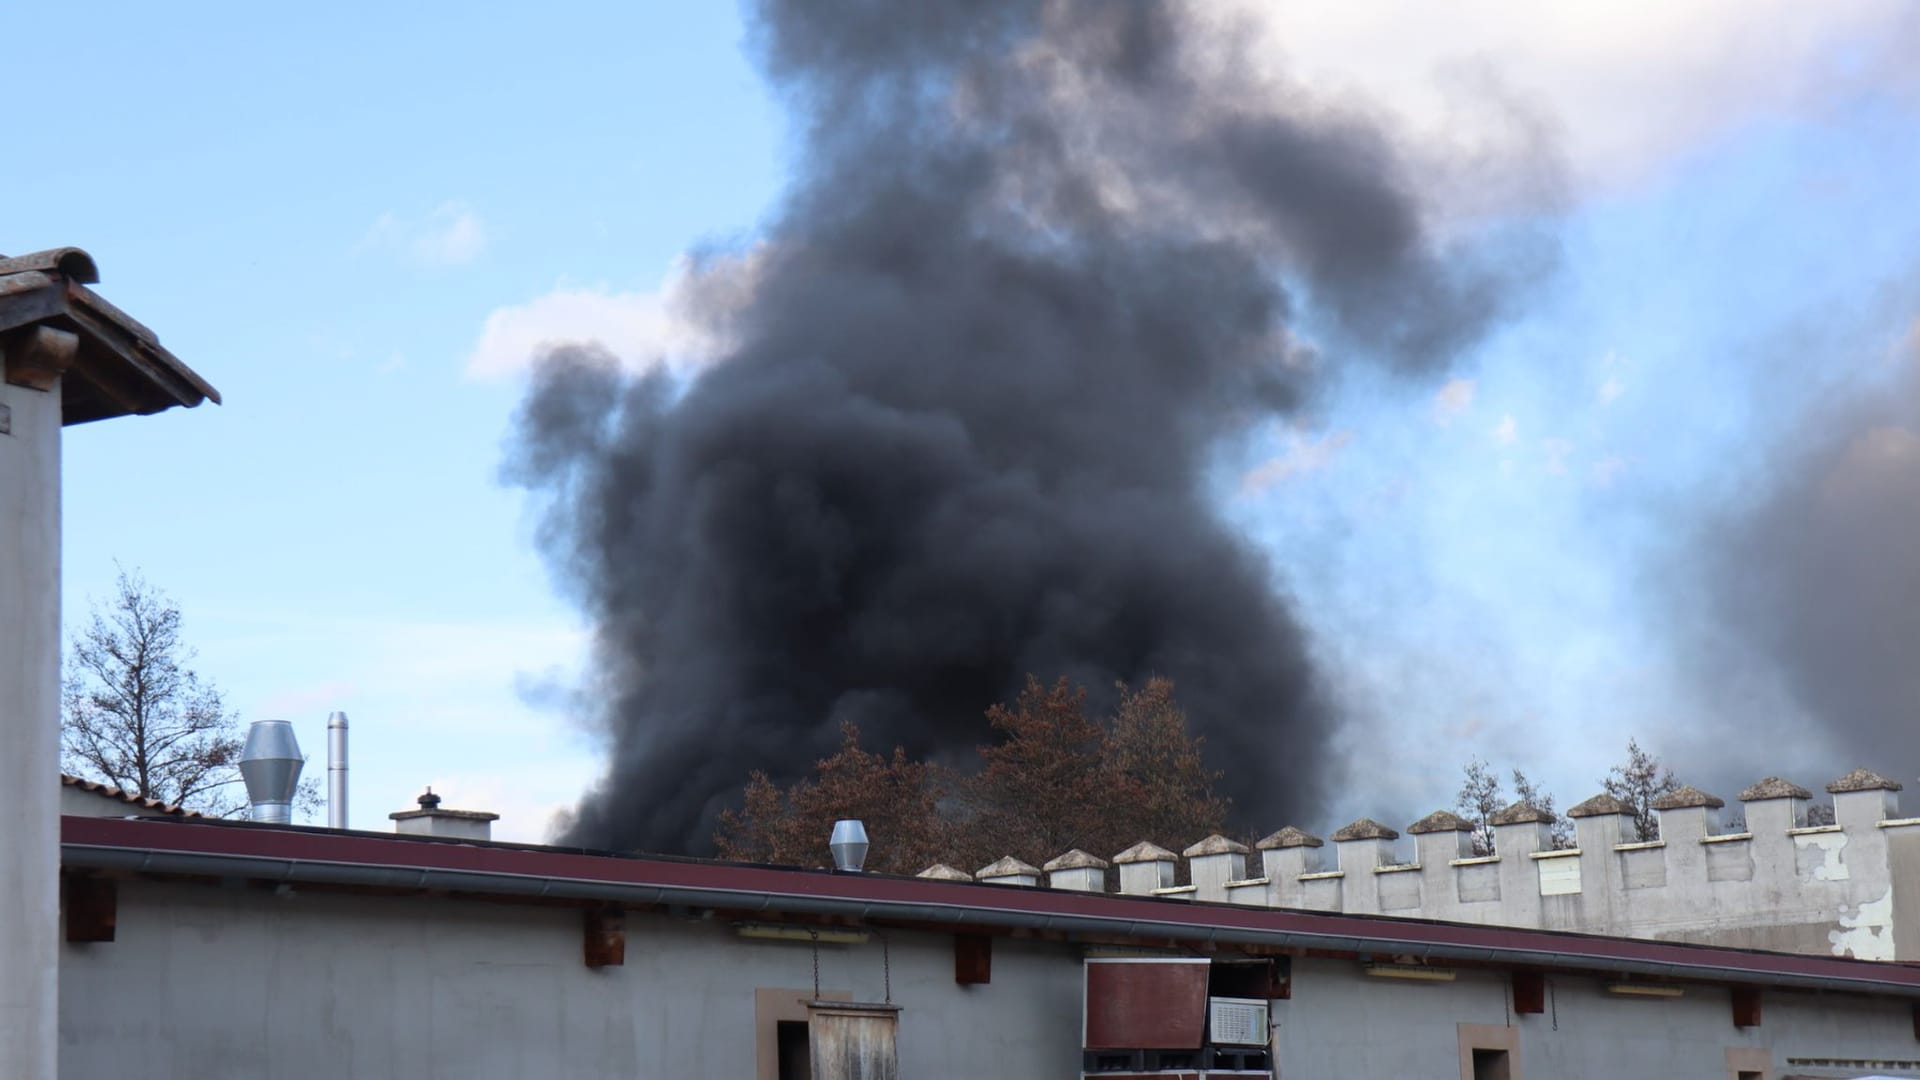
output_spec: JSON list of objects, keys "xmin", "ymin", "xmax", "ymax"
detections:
[{"xmin": 60, "ymin": 882, "xmax": 1081, "ymax": 1080}]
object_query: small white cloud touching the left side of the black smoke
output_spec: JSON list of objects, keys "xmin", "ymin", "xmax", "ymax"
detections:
[{"xmin": 467, "ymin": 250, "xmax": 762, "ymax": 379}]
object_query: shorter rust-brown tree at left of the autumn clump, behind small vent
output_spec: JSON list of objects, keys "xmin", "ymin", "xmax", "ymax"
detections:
[{"xmin": 714, "ymin": 723, "xmax": 950, "ymax": 874}]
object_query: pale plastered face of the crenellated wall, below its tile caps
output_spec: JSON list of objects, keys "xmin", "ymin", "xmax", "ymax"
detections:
[{"xmin": 1090, "ymin": 790, "xmax": 1920, "ymax": 961}]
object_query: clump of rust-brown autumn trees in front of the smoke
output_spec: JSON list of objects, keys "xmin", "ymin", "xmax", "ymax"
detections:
[{"xmin": 714, "ymin": 676, "xmax": 1229, "ymax": 874}]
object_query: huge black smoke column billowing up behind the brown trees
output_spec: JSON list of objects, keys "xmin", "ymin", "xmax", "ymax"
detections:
[{"xmin": 509, "ymin": 0, "xmax": 1551, "ymax": 851}]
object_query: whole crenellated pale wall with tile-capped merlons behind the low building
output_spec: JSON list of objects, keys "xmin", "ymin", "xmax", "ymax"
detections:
[{"xmin": 925, "ymin": 769, "xmax": 1920, "ymax": 961}]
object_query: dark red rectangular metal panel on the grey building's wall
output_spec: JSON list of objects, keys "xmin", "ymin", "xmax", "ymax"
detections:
[{"xmin": 1087, "ymin": 959, "xmax": 1210, "ymax": 1049}]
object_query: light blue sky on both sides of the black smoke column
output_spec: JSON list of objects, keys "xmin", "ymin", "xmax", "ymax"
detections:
[{"xmin": 0, "ymin": 4, "xmax": 1920, "ymax": 840}]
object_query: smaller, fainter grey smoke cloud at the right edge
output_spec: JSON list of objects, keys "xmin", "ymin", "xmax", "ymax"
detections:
[{"xmin": 1692, "ymin": 336, "xmax": 1920, "ymax": 786}]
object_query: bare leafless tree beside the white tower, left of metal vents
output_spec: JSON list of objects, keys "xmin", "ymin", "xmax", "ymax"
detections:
[{"xmin": 60, "ymin": 571, "xmax": 319, "ymax": 817}]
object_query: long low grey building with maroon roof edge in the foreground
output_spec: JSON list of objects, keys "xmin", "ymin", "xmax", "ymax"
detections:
[{"xmin": 60, "ymin": 807, "xmax": 1920, "ymax": 1080}]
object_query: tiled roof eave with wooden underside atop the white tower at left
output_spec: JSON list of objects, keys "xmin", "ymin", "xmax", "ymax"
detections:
[{"xmin": 0, "ymin": 248, "xmax": 221, "ymax": 425}]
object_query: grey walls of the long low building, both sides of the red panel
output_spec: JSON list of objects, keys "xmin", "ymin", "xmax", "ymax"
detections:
[{"xmin": 60, "ymin": 882, "xmax": 1920, "ymax": 1080}]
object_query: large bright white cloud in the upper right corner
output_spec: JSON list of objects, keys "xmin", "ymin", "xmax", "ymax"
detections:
[{"xmin": 1240, "ymin": 0, "xmax": 1920, "ymax": 186}]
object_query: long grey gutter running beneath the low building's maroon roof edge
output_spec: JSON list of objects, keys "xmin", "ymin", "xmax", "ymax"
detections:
[{"xmin": 61, "ymin": 844, "xmax": 1920, "ymax": 997}]
